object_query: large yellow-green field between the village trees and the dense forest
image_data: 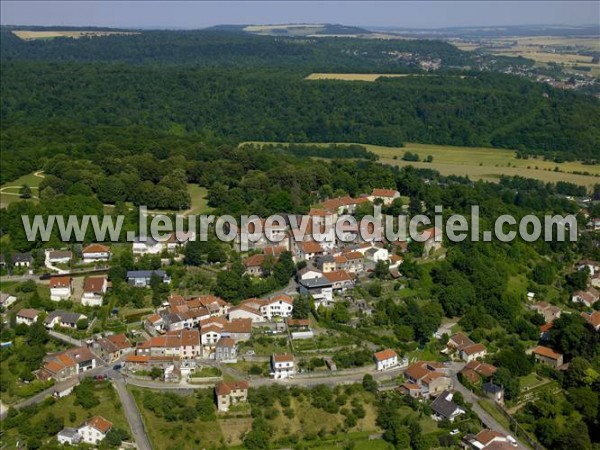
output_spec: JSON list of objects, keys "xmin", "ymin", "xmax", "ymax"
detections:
[{"xmin": 246, "ymin": 142, "xmax": 600, "ymax": 187}]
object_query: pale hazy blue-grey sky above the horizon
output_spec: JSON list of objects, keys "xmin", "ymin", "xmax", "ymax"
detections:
[{"xmin": 0, "ymin": 0, "xmax": 600, "ymax": 28}]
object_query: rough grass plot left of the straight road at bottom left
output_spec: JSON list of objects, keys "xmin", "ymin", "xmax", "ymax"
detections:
[{"xmin": 2, "ymin": 382, "xmax": 131, "ymax": 448}]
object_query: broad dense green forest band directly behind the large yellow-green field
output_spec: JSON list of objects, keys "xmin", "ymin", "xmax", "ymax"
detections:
[{"xmin": 1, "ymin": 62, "xmax": 600, "ymax": 182}]
